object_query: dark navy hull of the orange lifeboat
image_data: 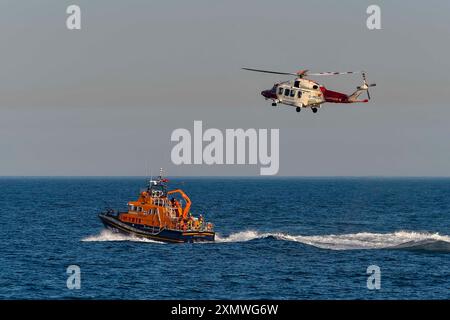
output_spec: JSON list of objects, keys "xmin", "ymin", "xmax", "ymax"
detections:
[{"xmin": 98, "ymin": 213, "xmax": 215, "ymax": 243}]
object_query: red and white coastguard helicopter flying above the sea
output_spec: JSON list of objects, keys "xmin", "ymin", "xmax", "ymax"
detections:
[{"xmin": 242, "ymin": 68, "xmax": 376, "ymax": 113}]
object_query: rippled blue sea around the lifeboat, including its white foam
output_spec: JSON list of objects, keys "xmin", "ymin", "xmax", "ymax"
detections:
[{"xmin": 0, "ymin": 178, "xmax": 450, "ymax": 299}]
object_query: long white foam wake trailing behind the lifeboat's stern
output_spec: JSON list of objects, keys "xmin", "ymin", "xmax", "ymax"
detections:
[{"xmin": 216, "ymin": 230, "xmax": 450, "ymax": 252}]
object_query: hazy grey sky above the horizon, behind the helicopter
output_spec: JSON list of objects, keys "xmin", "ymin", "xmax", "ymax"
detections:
[{"xmin": 0, "ymin": 0, "xmax": 450, "ymax": 176}]
